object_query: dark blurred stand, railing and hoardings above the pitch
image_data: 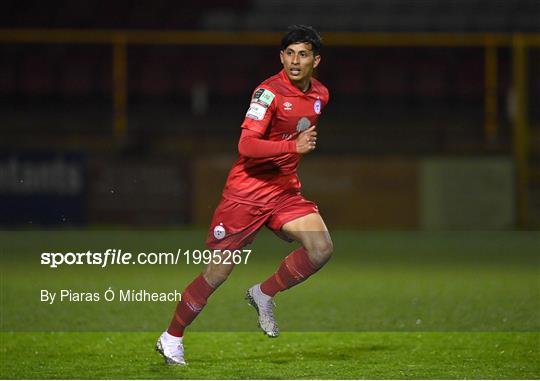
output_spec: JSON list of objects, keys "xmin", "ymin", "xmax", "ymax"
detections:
[{"xmin": 0, "ymin": 0, "xmax": 540, "ymax": 229}]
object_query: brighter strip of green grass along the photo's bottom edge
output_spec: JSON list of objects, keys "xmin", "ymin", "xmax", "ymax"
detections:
[{"xmin": 0, "ymin": 332, "xmax": 540, "ymax": 379}]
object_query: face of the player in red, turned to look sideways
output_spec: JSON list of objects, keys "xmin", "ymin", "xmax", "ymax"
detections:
[{"xmin": 279, "ymin": 42, "xmax": 321, "ymax": 90}]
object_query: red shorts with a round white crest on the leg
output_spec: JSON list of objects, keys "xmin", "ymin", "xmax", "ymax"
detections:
[{"xmin": 206, "ymin": 193, "xmax": 319, "ymax": 250}]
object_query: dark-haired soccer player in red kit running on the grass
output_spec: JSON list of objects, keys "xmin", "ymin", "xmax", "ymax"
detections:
[{"xmin": 156, "ymin": 25, "xmax": 333, "ymax": 365}]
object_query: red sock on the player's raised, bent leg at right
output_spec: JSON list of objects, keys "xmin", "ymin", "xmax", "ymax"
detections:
[{"xmin": 261, "ymin": 247, "xmax": 318, "ymax": 297}]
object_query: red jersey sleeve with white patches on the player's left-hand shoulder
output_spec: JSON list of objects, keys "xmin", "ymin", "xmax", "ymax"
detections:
[{"xmin": 241, "ymin": 86, "xmax": 277, "ymax": 134}]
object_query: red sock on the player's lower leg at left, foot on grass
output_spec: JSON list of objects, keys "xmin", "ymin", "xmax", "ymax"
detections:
[{"xmin": 167, "ymin": 274, "xmax": 215, "ymax": 337}]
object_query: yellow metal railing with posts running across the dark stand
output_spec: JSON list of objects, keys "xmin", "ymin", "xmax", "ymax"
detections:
[{"xmin": 0, "ymin": 29, "xmax": 540, "ymax": 226}]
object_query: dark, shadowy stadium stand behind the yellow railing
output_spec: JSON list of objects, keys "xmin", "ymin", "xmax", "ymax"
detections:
[{"xmin": 0, "ymin": 0, "xmax": 540, "ymax": 226}]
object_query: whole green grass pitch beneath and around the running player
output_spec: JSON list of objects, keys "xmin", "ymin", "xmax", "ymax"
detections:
[{"xmin": 0, "ymin": 230, "xmax": 540, "ymax": 379}]
